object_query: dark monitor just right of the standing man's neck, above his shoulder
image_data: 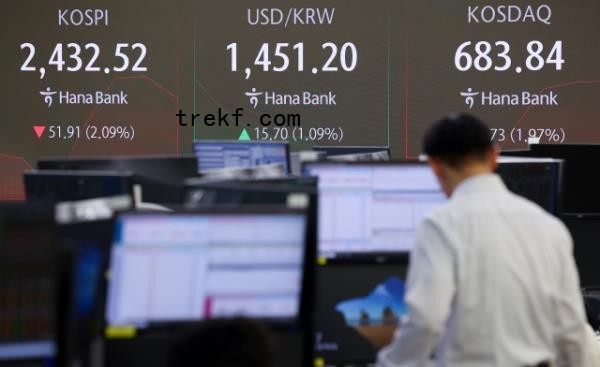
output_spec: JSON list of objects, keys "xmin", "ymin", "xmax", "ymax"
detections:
[{"xmin": 496, "ymin": 157, "xmax": 563, "ymax": 215}]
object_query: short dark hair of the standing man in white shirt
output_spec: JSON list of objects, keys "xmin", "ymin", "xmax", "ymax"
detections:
[{"xmin": 423, "ymin": 114, "xmax": 493, "ymax": 168}]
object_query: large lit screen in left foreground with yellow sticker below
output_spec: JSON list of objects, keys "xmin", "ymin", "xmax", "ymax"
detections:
[{"xmin": 106, "ymin": 212, "xmax": 306, "ymax": 328}]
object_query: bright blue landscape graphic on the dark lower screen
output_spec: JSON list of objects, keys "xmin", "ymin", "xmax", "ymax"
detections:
[{"xmin": 335, "ymin": 277, "xmax": 406, "ymax": 328}]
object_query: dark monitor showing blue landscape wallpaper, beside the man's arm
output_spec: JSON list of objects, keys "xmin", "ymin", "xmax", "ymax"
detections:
[{"xmin": 315, "ymin": 260, "xmax": 408, "ymax": 366}]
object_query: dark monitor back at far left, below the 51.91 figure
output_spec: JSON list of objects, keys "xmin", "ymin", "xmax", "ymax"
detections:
[{"xmin": 23, "ymin": 170, "xmax": 134, "ymax": 204}]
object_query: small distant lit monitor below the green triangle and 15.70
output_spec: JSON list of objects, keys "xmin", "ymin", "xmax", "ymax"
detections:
[{"xmin": 194, "ymin": 140, "xmax": 290, "ymax": 173}]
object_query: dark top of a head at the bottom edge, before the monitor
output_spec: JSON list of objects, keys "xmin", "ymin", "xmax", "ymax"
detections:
[{"xmin": 169, "ymin": 318, "xmax": 274, "ymax": 367}]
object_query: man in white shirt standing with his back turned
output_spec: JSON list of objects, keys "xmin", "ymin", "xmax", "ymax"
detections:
[{"xmin": 377, "ymin": 115, "xmax": 593, "ymax": 367}]
